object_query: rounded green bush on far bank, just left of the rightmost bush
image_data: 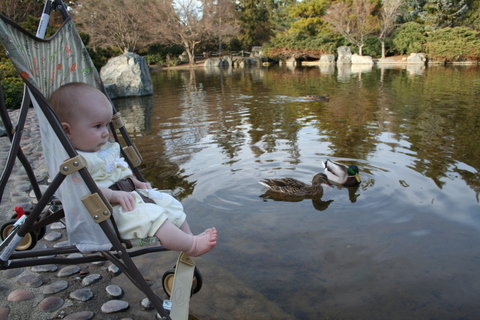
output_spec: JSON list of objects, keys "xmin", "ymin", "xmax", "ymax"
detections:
[{"xmin": 392, "ymin": 22, "xmax": 426, "ymax": 54}]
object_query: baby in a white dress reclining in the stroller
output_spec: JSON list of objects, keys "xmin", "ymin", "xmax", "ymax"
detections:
[{"xmin": 50, "ymin": 83, "xmax": 217, "ymax": 257}]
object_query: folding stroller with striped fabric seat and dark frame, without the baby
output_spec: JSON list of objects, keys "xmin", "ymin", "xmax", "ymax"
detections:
[{"xmin": 0, "ymin": 0, "xmax": 202, "ymax": 319}]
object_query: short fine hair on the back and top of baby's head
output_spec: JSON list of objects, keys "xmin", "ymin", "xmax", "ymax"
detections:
[{"xmin": 50, "ymin": 82, "xmax": 100, "ymax": 122}]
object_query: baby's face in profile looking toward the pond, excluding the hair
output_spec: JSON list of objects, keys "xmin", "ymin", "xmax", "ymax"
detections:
[{"xmin": 68, "ymin": 92, "xmax": 112, "ymax": 152}]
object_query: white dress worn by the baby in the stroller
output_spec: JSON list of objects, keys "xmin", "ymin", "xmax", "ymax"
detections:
[{"xmin": 78, "ymin": 142, "xmax": 186, "ymax": 240}]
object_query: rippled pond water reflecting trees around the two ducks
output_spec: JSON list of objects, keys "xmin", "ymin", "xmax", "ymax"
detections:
[{"xmin": 115, "ymin": 66, "xmax": 480, "ymax": 320}]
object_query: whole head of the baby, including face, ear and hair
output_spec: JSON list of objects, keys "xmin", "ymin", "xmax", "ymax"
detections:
[{"xmin": 50, "ymin": 82, "xmax": 112, "ymax": 152}]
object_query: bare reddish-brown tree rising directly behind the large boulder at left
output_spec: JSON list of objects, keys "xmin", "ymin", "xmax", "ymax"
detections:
[{"xmin": 72, "ymin": 0, "xmax": 152, "ymax": 52}]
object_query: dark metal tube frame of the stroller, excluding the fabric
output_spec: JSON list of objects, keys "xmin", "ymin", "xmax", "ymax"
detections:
[{"xmin": 0, "ymin": 0, "xmax": 201, "ymax": 319}]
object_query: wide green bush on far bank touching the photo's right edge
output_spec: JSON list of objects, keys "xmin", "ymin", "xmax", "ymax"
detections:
[{"xmin": 426, "ymin": 27, "xmax": 480, "ymax": 62}]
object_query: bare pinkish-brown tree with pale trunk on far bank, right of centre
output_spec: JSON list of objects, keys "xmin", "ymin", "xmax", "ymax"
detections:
[{"xmin": 323, "ymin": 0, "xmax": 378, "ymax": 55}]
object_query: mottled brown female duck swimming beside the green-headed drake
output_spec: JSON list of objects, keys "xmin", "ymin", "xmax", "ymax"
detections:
[{"xmin": 258, "ymin": 173, "xmax": 332, "ymax": 197}]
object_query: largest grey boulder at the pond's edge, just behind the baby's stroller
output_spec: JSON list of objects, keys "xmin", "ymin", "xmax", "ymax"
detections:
[{"xmin": 100, "ymin": 52, "xmax": 153, "ymax": 99}]
